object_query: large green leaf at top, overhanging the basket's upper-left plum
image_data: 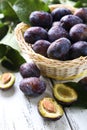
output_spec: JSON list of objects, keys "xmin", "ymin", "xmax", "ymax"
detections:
[{"xmin": 13, "ymin": 0, "xmax": 49, "ymax": 24}]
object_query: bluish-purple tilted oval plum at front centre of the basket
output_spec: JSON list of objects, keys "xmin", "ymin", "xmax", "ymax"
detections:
[{"xmin": 47, "ymin": 38, "xmax": 71, "ymax": 60}]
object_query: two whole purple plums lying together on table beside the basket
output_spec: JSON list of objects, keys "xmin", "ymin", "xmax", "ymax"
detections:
[{"xmin": 19, "ymin": 62, "xmax": 46, "ymax": 96}]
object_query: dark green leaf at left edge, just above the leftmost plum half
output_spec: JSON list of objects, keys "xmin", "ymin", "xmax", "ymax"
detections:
[{"xmin": 0, "ymin": 44, "xmax": 26, "ymax": 71}]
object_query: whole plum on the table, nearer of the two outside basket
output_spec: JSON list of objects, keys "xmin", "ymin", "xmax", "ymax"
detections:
[{"xmin": 19, "ymin": 77, "xmax": 46, "ymax": 96}]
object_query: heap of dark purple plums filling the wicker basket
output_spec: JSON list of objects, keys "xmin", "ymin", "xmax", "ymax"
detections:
[{"xmin": 24, "ymin": 8, "xmax": 87, "ymax": 60}]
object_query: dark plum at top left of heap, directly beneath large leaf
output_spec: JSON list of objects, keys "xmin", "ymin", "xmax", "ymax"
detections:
[{"xmin": 29, "ymin": 11, "xmax": 53, "ymax": 28}]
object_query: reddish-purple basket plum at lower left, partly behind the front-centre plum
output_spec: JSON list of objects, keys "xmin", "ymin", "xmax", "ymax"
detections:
[{"xmin": 32, "ymin": 40, "xmax": 51, "ymax": 56}]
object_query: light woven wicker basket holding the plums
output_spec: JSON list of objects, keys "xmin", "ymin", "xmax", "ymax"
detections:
[{"xmin": 15, "ymin": 5, "xmax": 87, "ymax": 82}]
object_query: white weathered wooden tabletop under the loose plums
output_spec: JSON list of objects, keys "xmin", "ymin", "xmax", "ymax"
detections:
[{"xmin": 0, "ymin": 56, "xmax": 87, "ymax": 130}]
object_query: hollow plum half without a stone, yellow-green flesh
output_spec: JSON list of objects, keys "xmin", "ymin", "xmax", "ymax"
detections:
[{"xmin": 53, "ymin": 84, "xmax": 78, "ymax": 106}]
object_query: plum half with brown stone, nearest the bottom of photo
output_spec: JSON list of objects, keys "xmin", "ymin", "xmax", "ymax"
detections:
[{"xmin": 38, "ymin": 97, "xmax": 64, "ymax": 120}]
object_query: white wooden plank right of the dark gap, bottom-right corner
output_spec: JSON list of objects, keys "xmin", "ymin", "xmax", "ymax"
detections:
[{"xmin": 66, "ymin": 107, "xmax": 87, "ymax": 130}]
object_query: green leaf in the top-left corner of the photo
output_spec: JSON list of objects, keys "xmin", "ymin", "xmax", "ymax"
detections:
[{"xmin": 0, "ymin": 0, "xmax": 18, "ymax": 21}]
